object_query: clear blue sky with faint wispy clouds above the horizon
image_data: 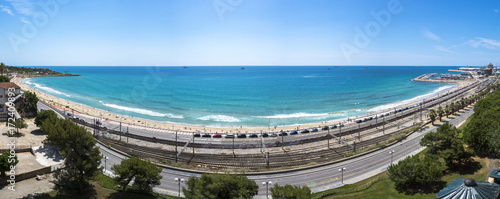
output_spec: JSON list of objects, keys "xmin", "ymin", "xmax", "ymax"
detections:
[{"xmin": 0, "ymin": 0, "xmax": 500, "ymax": 66}]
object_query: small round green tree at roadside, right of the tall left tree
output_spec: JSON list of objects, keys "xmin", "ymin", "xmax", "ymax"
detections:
[{"xmin": 111, "ymin": 157, "xmax": 162, "ymax": 191}]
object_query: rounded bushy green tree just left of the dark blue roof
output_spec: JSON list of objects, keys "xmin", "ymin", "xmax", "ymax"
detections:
[{"xmin": 388, "ymin": 155, "xmax": 443, "ymax": 193}]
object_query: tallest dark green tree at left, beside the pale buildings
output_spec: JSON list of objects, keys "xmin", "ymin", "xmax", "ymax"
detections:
[{"xmin": 40, "ymin": 118, "xmax": 102, "ymax": 191}]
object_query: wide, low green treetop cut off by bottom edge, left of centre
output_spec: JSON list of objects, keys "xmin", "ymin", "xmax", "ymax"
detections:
[{"xmin": 182, "ymin": 173, "xmax": 259, "ymax": 199}]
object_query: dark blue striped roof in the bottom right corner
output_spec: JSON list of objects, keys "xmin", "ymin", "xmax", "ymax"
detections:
[{"xmin": 436, "ymin": 177, "xmax": 500, "ymax": 199}]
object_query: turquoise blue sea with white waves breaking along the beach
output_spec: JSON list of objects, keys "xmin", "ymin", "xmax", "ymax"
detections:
[{"xmin": 24, "ymin": 66, "xmax": 460, "ymax": 126}]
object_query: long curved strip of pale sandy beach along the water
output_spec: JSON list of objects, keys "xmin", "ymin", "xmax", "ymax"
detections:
[{"xmin": 12, "ymin": 77, "xmax": 471, "ymax": 134}]
